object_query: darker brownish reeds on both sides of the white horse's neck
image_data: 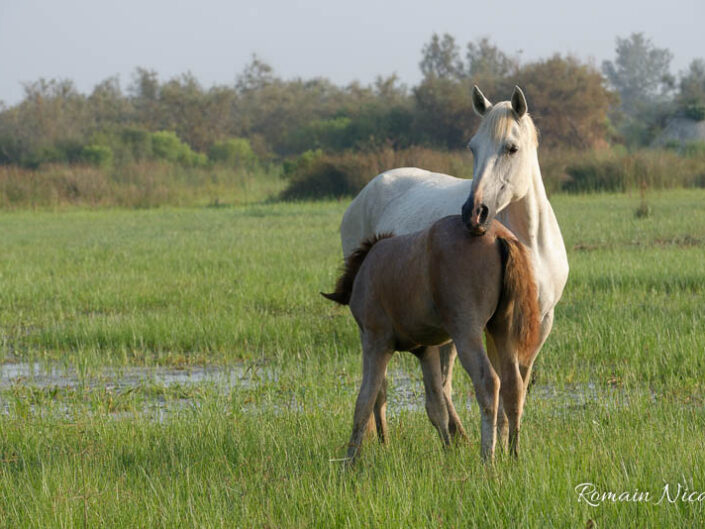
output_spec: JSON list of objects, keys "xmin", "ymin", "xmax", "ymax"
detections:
[{"xmin": 282, "ymin": 148, "xmax": 705, "ymax": 199}]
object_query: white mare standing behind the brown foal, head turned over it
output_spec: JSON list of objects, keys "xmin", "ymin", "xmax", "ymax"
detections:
[{"xmin": 340, "ymin": 86, "xmax": 568, "ymax": 446}]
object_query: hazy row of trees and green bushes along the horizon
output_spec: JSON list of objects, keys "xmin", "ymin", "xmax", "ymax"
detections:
[{"xmin": 0, "ymin": 33, "xmax": 705, "ymax": 167}]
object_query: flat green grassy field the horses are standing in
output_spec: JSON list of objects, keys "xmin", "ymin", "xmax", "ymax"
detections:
[{"xmin": 0, "ymin": 190, "xmax": 705, "ymax": 528}]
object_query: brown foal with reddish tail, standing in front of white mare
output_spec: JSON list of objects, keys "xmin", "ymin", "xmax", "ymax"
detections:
[{"xmin": 323, "ymin": 215, "xmax": 539, "ymax": 461}]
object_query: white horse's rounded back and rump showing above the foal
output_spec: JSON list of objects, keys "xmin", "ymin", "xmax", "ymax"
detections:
[{"xmin": 340, "ymin": 167, "xmax": 471, "ymax": 256}]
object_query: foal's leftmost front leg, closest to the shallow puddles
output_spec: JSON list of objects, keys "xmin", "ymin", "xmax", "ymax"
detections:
[{"xmin": 347, "ymin": 336, "xmax": 393, "ymax": 462}]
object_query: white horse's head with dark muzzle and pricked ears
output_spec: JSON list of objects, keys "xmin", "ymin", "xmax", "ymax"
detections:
[{"xmin": 462, "ymin": 86, "xmax": 538, "ymax": 235}]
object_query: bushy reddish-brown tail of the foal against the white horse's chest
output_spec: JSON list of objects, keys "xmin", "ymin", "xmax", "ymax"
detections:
[{"xmin": 497, "ymin": 234, "xmax": 540, "ymax": 364}]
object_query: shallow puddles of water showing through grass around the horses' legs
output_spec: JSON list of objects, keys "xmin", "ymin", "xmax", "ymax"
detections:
[{"xmin": 0, "ymin": 362, "xmax": 655, "ymax": 420}]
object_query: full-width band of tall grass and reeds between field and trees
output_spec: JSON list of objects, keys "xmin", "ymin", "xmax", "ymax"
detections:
[{"xmin": 5, "ymin": 147, "xmax": 705, "ymax": 209}]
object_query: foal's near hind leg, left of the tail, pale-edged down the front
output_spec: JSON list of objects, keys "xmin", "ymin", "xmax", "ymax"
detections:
[{"xmin": 453, "ymin": 330, "xmax": 500, "ymax": 461}]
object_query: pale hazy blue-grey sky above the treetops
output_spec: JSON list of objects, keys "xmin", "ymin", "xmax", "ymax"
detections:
[{"xmin": 0, "ymin": 0, "xmax": 705, "ymax": 105}]
